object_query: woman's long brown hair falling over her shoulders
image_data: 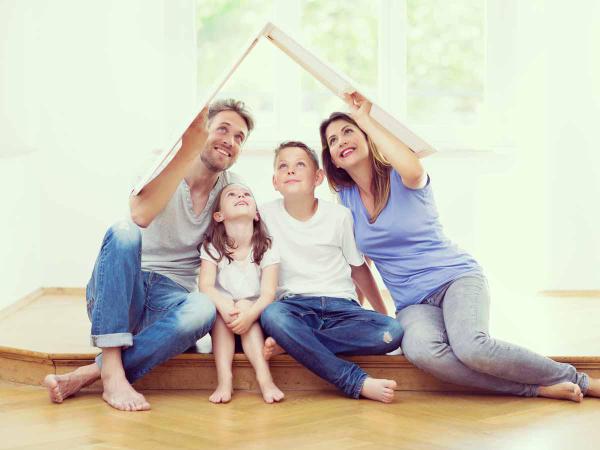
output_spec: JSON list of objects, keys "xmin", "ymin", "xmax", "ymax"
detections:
[{"xmin": 319, "ymin": 112, "xmax": 392, "ymax": 223}]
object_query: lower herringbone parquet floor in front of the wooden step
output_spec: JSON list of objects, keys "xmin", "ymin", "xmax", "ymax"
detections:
[{"xmin": 0, "ymin": 381, "xmax": 600, "ymax": 450}]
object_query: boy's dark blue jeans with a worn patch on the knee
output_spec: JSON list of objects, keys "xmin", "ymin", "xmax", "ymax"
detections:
[{"xmin": 261, "ymin": 295, "xmax": 402, "ymax": 398}]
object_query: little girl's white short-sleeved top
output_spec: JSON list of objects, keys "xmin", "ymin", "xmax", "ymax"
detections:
[{"xmin": 200, "ymin": 244, "xmax": 279, "ymax": 300}]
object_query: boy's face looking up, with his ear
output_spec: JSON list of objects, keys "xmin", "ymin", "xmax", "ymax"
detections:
[{"xmin": 273, "ymin": 147, "xmax": 324, "ymax": 198}]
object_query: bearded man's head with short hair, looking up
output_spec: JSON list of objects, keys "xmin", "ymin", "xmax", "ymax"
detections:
[{"xmin": 200, "ymin": 99, "xmax": 254, "ymax": 172}]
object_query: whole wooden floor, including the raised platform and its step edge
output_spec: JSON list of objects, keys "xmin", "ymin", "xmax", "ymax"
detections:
[{"xmin": 0, "ymin": 289, "xmax": 600, "ymax": 450}]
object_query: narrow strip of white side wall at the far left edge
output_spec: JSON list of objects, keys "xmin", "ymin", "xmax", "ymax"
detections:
[{"xmin": 0, "ymin": 2, "xmax": 42, "ymax": 308}]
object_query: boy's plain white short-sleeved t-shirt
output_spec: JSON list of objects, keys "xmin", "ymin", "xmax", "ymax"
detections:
[{"xmin": 259, "ymin": 199, "xmax": 364, "ymax": 299}]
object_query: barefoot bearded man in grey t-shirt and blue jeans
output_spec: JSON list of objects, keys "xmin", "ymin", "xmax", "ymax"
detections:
[{"xmin": 44, "ymin": 100, "xmax": 254, "ymax": 411}]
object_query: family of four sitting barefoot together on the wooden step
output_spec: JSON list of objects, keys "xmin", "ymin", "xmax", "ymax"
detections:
[{"xmin": 44, "ymin": 96, "xmax": 600, "ymax": 411}]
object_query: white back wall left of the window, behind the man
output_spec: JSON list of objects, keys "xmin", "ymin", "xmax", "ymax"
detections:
[{"xmin": 36, "ymin": 0, "xmax": 195, "ymax": 286}]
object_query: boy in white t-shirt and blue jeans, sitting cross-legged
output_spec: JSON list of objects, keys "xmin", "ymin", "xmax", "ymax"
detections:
[{"xmin": 260, "ymin": 141, "xmax": 402, "ymax": 403}]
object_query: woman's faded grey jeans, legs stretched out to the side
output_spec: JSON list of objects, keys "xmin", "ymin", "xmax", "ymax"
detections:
[{"xmin": 396, "ymin": 275, "xmax": 589, "ymax": 397}]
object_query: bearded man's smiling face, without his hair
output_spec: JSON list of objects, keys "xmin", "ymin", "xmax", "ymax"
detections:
[{"xmin": 200, "ymin": 111, "xmax": 248, "ymax": 172}]
